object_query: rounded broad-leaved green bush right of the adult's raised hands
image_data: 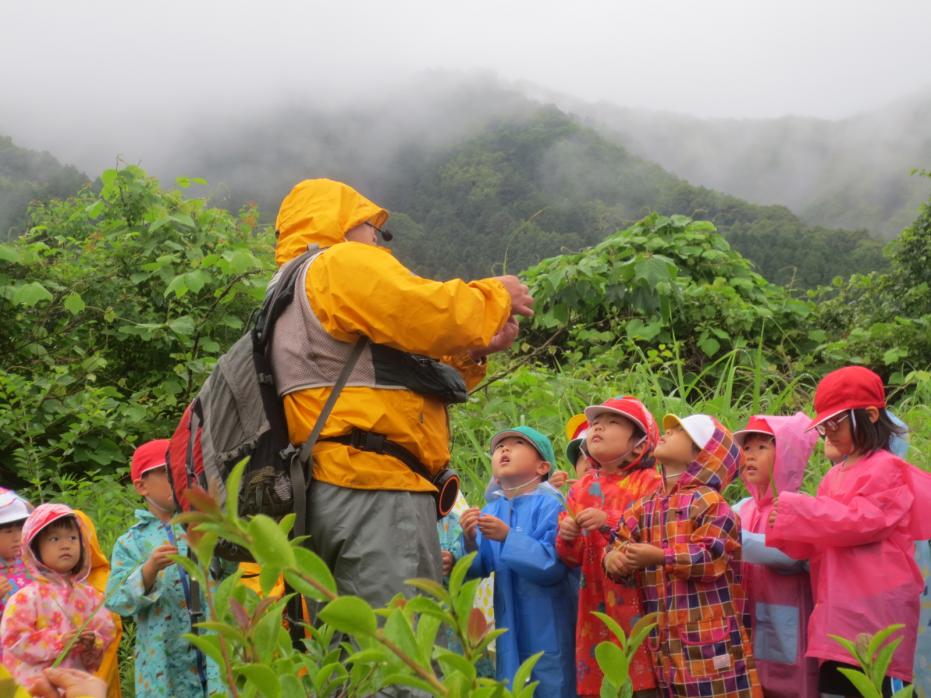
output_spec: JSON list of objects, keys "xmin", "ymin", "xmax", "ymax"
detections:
[{"xmin": 523, "ymin": 214, "xmax": 811, "ymax": 372}]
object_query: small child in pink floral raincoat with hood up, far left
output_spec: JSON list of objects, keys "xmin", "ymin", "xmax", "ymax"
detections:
[{"xmin": 0, "ymin": 504, "xmax": 115, "ymax": 687}]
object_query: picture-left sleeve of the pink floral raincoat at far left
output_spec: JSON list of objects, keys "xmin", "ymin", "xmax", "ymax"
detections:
[{"xmin": 0, "ymin": 584, "xmax": 65, "ymax": 665}]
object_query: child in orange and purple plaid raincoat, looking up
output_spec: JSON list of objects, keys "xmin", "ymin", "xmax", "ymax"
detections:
[{"xmin": 605, "ymin": 414, "xmax": 763, "ymax": 698}]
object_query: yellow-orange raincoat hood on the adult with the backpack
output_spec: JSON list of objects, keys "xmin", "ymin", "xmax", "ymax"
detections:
[{"xmin": 275, "ymin": 179, "xmax": 388, "ymax": 266}]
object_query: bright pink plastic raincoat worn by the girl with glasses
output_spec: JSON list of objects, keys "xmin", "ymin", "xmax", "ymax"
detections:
[{"xmin": 767, "ymin": 450, "xmax": 931, "ymax": 681}]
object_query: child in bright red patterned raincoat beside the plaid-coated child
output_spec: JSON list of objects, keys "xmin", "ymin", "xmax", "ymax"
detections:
[{"xmin": 556, "ymin": 397, "xmax": 661, "ymax": 696}]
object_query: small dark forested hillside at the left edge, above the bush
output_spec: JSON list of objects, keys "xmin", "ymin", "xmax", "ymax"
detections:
[{"xmin": 0, "ymin": 135, "xmax": 87, "ymax": 240}]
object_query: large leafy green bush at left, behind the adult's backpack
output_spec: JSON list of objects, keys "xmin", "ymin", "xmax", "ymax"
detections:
[{"xmin": 0, "ymin": 166, "xmax": 273, "ymax": 485}]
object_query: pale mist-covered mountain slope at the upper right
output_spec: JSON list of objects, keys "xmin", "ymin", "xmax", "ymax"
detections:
[{"xmin": 576, "ymin": 90, "xmax": 931, "ymax": 239}]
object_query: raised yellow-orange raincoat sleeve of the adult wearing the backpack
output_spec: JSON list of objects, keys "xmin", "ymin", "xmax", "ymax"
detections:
[{"xmin": 307, "ymin": 243, "xmax": 511, "ymax": 359}]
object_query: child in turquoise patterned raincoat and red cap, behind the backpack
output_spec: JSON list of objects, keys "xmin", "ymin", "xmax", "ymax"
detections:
[{"xmin": 107, "ymin": 439, "xmax": 224, "ymax": 698}]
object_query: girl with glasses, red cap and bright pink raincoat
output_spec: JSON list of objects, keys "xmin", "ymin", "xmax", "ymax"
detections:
[{"xmin": 766, "ymin": 366, "xmax": 931, "ymax": 696}]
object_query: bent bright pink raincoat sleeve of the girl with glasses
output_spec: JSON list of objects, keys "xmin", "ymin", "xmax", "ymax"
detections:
[{"xmin": 770, "ymin": 468, "xmax": 914, "ymax": 557}]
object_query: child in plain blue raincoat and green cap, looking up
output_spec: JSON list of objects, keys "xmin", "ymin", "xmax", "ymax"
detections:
[{"xmin": 460, "ymin": 426, "xmax": 578, "ymax": 698}]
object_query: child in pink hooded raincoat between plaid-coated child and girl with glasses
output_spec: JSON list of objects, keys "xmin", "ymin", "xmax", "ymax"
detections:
[{"xmin": 734, "ymin": 412, "xmax": 819, "ymax": 698}]
